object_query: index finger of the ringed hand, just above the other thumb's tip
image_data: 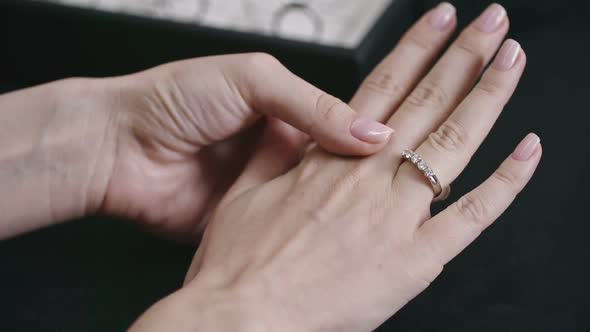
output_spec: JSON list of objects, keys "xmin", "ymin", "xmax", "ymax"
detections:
[{"xmin": 350, "ymin": 2, "xmax": 457, "ymax": 122}]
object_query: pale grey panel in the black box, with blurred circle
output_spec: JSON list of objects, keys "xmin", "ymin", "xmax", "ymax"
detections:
[{"xmin": 45, "ymin": 0, "xmax": 391, "ymax": 47}]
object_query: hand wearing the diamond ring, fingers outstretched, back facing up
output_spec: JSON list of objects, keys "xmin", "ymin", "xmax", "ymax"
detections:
[{"xmin": 135, "ymin": 4, "xmax": 542, "ymax": 331}]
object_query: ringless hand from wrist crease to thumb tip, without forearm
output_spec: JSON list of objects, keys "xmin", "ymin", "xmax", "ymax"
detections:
[{"xmin": 99, "ymin": 54, "xmax": 392, "ymax": 238}]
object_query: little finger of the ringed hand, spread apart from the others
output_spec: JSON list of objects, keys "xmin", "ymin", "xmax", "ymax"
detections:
[{"xmin": 416, "ymin": 134, "xmax": 542, "ymax": 264}]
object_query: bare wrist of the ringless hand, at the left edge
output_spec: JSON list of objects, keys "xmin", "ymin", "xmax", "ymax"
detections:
[{"xmin": 0, "ymin": 79, "xmax": 120, "ymax": 238}]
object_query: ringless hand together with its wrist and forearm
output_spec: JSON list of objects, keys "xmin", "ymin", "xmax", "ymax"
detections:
[{"xmin": 0, "ymin": 53, "xmax": 391, "ymax": 242}]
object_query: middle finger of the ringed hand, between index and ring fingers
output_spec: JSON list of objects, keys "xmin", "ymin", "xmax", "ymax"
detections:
[{"xmin": 388, "ymin": 4, "xmax": 509, "ymax": 152}]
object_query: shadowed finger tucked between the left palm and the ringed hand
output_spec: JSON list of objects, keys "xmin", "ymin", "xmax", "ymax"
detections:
[{"xmin": 223, "ymin": 118, "xmax": 309, "ymax": 202}]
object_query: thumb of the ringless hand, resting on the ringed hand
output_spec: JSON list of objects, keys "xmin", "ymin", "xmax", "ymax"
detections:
[{"xmin": 225, "ymin": 53, "xmax": 393, "ymax": 156}]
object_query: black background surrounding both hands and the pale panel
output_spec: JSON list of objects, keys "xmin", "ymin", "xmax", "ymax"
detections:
[{"xmin": 0, "ymin": 0, "xmax": 590, "ymax": 331}]
